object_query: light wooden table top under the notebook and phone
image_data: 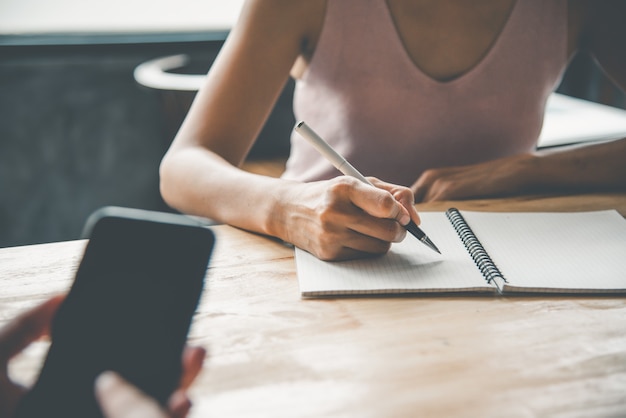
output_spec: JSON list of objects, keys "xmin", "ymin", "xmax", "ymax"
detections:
[{"xmin": 0, "ymin": 194, "xmax": 626, "ymax": 417}]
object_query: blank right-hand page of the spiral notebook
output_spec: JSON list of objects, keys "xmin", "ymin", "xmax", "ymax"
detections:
[{"xmin": 462, "ymin": 211, "xmax": 626, "ymax": 292}]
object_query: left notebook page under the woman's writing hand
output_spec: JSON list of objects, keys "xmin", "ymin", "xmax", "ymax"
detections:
[{"xmin": 295, "ymin": 212, "xmax": 494, "ymax": 296}]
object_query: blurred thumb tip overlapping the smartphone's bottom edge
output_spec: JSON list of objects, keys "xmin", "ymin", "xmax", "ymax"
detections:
[{"xmin": 95, "ymin": 372, "xmax": 168, "ymax": 418}]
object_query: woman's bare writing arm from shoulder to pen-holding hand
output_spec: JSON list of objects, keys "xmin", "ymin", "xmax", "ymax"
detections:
[{"xmin": 160, "ymin": 0, "xmax": 419, "ymax": 259}]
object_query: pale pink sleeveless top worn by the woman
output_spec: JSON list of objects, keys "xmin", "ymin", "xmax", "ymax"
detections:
[{"xmin": 283, "ymin": 0, "xmax": 568, "ymax": 186}]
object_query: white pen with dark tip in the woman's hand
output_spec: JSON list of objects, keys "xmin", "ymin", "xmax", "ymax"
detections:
[{"xmin": 294, "ymin": 121, "xmax": 441, "ymax": 254}]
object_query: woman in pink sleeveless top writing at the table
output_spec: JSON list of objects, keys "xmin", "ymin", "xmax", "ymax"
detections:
[{"xmin": 161, "ymin": 0, "xmax": 626, "ymax": 260}]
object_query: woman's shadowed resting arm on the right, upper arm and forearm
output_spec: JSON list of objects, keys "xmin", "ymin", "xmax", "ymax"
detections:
[{"xmin": 412, "ymin": 0, "xmax": 626, "ymax": 201}]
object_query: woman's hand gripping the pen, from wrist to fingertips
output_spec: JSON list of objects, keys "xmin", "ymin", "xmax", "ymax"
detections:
[{"xmin": 278, "ymin": 176, "xmax": 420, "ymax": 260}]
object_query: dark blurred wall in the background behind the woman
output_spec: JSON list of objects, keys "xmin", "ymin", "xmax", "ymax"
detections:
[{"xmin": 0, "ymin": 29, "xmax": 625, "ymax": 247}]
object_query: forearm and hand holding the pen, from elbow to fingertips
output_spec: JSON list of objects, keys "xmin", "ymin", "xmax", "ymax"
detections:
[{"xmin": 161, "ymin": 146, "xmax": 419, "ymax": 260}]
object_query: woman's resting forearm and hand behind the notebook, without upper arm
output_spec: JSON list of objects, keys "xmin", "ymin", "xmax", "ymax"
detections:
[{"xmin": 412, "ymin": 139, "xmax": 626, "ymax": 202}]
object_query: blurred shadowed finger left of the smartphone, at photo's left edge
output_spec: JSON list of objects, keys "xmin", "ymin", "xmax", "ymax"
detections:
[{"xmin": 0, "ymin": 295, "xmax": 64, "ymax": 361}]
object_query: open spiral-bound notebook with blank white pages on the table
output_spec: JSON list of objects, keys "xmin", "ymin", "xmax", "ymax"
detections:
[{"xmin": 295, "ymin": 209, "xmax": 626, "ymax": 297}]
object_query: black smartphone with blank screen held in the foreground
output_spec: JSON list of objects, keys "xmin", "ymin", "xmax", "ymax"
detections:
[{"xmin": 16, "ymin": 207, "xmax": 215, "ymax": 418}]
